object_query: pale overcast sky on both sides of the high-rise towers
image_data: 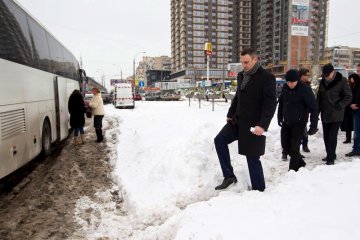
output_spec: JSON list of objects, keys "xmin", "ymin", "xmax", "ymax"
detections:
[{"xmin": 17, "ymin": 0, "xmax": 360, "ymax": 88}]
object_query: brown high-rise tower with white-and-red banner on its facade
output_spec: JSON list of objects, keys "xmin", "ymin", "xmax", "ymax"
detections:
[{"xmin": 252, "ymin": 0, "xmax": 329, "ymax": 75}]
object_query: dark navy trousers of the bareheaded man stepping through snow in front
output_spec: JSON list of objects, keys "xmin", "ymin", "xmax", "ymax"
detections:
[{"xmin": 214, "ymin": 123, "xmax": 265, "ymax": 191}]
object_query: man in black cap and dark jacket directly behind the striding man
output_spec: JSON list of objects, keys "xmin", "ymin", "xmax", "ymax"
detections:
[{"xmin": 278, "ymin": 69, "xmax": 318, "ymax": 171}]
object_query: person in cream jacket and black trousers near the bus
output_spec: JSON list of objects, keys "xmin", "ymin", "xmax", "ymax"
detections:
[{"xmin": 89, "ymin": 88, "xmax": 105, "ymax": 143}]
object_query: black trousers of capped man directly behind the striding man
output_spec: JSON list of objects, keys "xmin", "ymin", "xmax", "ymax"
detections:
[{"xmin": 280, "ymin": 124, "xmax": 306, "ymax": 171}]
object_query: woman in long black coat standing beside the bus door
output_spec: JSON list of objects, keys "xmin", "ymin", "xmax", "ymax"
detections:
[{"xmin": 68, "ymin": 89, "xmax": 85, "ymax": 145}]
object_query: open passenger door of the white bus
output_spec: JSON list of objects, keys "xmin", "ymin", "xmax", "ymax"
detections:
[{"xmin": 54, "ymin": 76, "xmax": 69, "ymax": 141}]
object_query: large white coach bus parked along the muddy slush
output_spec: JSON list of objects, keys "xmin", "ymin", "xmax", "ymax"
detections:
[{"xmin": 0, "ymin": 0, "xmax": 84, "ymax": 178}]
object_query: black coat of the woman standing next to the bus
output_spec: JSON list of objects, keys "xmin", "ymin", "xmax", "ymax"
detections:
[{"xmin": 68, "ymin": 94, "xmax": 85, "ymax": 128}]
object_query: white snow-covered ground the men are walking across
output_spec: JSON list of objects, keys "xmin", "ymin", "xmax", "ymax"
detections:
[{"xmin": 75, "ymin": 101, "xmax": 360, "ymax": 240}]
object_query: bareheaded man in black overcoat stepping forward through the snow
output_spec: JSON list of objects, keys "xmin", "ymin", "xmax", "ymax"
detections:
[{"xmin": 214, "ymin": 49, "xmax": 276, "ymax": 191}]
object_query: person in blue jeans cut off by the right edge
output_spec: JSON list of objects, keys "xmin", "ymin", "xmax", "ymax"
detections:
[{"xmin": 345, "ymin": 73, "xmax": 360, "ymax": 157}]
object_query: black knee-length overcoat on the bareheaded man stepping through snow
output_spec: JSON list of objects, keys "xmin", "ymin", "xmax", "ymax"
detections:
[{"xmin": 227, "ymin": 67, "xmax": 277, "ymax": 156}]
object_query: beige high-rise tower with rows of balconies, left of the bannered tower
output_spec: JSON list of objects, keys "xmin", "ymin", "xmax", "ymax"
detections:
[{"xmin": 171, "ymin": 0, "xmax": 251, "ymax": 80}]
